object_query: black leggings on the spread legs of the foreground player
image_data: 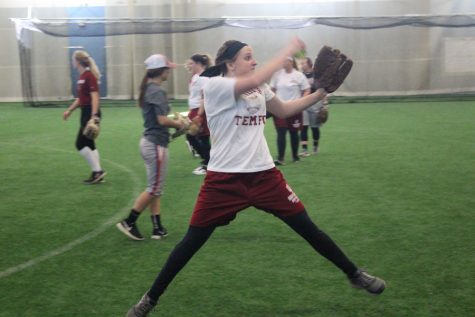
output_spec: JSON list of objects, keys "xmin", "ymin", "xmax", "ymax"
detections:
[{"xmin": 148, "ymin": 211, "xmax": 357, "ymax": 301}]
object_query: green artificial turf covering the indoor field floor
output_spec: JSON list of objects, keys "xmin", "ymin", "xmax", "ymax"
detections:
[{"xmin": 0, "ymin": 101, "xmax": 475, "ymax": 317}]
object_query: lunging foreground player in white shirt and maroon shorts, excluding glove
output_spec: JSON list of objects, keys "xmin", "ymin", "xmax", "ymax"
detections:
[{"xmin": 127, "ymin": 38, "xmax": 385, "ymax": 317}]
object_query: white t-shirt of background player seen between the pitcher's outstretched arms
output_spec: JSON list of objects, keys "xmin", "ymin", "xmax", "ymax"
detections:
[{"xmin": 270, "ymin": 69, "xmax": 310, "ymax": 101}]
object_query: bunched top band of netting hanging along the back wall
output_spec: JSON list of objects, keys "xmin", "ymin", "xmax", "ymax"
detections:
[{"xmin": 14, "ymin": 15, "xmax": 475, "ymax": 37}]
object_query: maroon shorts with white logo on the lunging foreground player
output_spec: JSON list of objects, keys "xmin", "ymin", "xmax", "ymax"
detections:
[{"xmin": 190, "ymin": 168, "xmax": 305, "ymax": 227}]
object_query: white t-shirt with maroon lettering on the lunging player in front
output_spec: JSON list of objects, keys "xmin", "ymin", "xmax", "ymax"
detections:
[{"xmin": 203, "ymin": 77, "xmax": 275, "ymax": 173}]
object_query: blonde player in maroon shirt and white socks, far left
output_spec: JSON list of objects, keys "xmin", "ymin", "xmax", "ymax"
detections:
[{"xmin": 63, "ymin": 51, "xmax": 106, "ymax": 184}]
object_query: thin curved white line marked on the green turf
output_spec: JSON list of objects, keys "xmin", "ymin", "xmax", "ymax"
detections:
[{"xmin": 0, "ymin": 142, "xmax": 140, "ymax": 279}]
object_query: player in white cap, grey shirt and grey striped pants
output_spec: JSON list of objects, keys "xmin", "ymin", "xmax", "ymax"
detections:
[{"xmin": 116, "ymin": 54, "xmax": 187, "ymax": 240}]
